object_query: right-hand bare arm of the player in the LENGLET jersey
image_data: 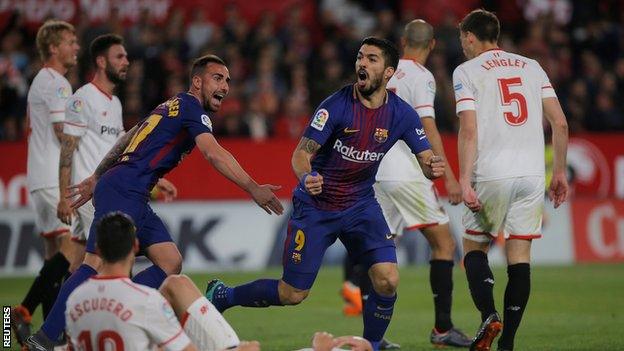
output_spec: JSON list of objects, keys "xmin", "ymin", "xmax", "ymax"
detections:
[{"xmin": 542, "ymin": 97, "xmax": 568, "ymax": 208}]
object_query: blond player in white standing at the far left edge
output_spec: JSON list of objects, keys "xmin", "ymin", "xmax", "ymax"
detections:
[{"xmin": 11, "ymin": 20, "xmax": 80, "ymax": 343}]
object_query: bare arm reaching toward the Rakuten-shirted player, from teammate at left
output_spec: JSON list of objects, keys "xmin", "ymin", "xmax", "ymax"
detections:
[{"xmin": 195, "ymin": 133, "xmax": 284, "ymax": 215}]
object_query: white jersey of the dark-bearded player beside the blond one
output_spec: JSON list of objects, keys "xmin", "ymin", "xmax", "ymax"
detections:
[{"xmin": 63, "ymin": 83, "xmax": 124, "ymax": 184}]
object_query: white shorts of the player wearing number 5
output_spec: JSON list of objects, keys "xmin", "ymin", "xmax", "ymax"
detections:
[{"xmin": 462, "ymin": 176, "xmax": 544, "ymax": 242}]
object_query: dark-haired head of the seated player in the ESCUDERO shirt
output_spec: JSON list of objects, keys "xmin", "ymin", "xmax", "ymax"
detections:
[{"xmin": 96, "ymin": 211, "xmax": 136, "ymax": 263}]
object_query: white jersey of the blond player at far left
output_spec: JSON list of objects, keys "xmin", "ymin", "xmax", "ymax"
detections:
[{"xmin": 26, "ymin": 67, "xmax": 72, "ymax": 191}]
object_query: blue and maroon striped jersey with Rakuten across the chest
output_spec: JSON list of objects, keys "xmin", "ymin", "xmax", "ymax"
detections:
[{"xmin": 294, "ymin": 85, "xmax": 430, "ymax": 210}]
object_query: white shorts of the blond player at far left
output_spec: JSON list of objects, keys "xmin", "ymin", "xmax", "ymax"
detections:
[{"xmin": 30, "ymin": 187, "xmax": 69, "ymax": 238}]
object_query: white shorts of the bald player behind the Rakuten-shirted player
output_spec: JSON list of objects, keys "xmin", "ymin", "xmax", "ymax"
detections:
[{"xmin": 373, "ymin": 181, "xmax": 449, "ymax": 235}]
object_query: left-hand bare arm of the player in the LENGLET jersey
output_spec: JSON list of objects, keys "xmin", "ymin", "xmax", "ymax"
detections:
[{"xmin": 457, "ymin": 110, "xmax": 481, "ymax": 212}]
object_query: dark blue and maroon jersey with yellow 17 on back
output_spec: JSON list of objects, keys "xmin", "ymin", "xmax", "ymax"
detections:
[{"xmin": 103, "ymin": 93, "xmax": 212, "ymax": 198}]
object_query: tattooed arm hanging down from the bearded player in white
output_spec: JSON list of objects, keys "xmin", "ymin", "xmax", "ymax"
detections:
[{"xmin": 56, "ymin": 133, "xmax": 80, "ymax": 224}]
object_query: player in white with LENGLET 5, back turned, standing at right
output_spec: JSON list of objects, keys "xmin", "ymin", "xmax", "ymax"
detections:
[{"xmin": 453, "ymin": 10, "xmax": 568, "ymax": 350}]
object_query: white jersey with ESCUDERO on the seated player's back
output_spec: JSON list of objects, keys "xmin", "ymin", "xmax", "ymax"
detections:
[{"xmin": 65, "ymin": 276, "xmax": 191, "ymax": 351}]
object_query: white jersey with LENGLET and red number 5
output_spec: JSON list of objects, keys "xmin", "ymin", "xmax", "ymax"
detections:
[{"xmin": 453, "ymin": 49, "xmax": 557, "ymax": 181}]
